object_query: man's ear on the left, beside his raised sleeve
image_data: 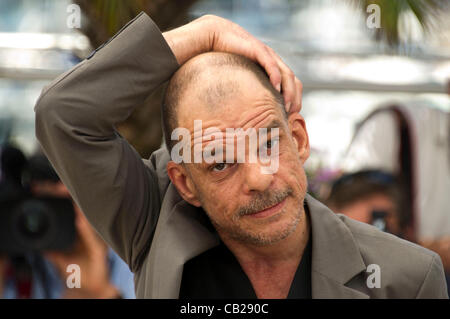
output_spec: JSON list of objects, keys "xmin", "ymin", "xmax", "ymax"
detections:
[{"xmin": 167, "ymin": 161, "xmax": 201, "ymax": 207}]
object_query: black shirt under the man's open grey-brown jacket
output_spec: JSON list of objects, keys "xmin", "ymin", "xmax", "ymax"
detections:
[{"xmin": 180, "ymin": 237, "xmax": 312, "ymax": 299}]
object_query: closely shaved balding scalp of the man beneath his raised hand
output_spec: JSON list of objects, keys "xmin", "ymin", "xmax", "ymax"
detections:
[{"xmin": 162, "ymin": 52, "xmax": 286, "ymax": 151}]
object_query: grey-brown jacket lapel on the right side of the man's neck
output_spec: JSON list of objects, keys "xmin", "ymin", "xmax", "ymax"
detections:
[{"xmin": 305, "ymin": 194, "xmax": 369, "ymax": 299}]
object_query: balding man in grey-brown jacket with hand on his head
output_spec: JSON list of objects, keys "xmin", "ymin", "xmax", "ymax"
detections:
[{"xmin": 36, "ymin": 14, "xmax": 448, "ymax": 298}]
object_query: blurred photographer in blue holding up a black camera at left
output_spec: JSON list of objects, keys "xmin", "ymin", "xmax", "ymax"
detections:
[{"xmin": 0, "ymin": 150, "xmax": 134, "ymax": 298}]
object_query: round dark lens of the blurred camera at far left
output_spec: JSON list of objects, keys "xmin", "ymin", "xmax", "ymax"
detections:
[{"xmin": 18, "ymin": 200, "xmax": 50, "ymax": 239}]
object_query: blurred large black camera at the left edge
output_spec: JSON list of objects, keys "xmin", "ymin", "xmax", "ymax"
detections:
[{"xmin": 0, "ymin": 147, "xmax": 76, "ymax": 255}]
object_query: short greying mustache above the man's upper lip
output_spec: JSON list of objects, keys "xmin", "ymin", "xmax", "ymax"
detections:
[{"xmin": 237, "ymin": 187, "xmax": 293, "ymax": 216}]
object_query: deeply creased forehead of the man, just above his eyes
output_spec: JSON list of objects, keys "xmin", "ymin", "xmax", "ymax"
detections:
[{"xmin": 172, "ymin": 91, "xmax": 287, "ymax": 170}]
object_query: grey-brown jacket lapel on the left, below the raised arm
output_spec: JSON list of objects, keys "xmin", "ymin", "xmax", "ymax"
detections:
[{"xmin": 146, "ymin": 184, "xmax": 219, "ymax": 299}]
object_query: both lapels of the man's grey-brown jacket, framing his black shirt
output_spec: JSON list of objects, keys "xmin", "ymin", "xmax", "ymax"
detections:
[{"xmin": 145, "ymin": 189, "xmax": 368, "ymax": 298}]
